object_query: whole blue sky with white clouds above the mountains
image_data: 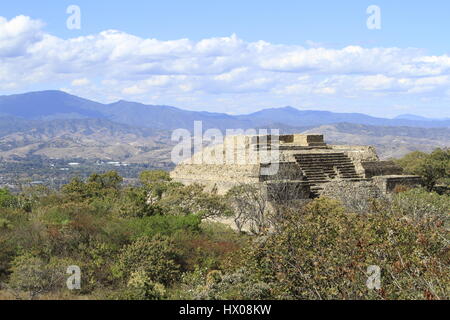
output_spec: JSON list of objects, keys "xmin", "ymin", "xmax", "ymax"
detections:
[{"xmin": 0, "ymin": 0, "xmax": 450, "ymax": 118}]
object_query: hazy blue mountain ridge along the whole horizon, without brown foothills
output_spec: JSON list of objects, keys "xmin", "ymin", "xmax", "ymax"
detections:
[{"xmin": 0, "ymin": 91, "xmax": 450, "ymax": 130}]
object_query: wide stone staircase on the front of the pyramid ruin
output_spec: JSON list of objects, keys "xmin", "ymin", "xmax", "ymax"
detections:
[{"xmin": 295, "ymin": 152, "xmax": 363, "ymax": 198}]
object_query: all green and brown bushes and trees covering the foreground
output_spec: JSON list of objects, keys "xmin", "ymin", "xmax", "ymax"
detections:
[{"xmin": 0, "ymin": 171, "xmax": 450, "ymax": 300}]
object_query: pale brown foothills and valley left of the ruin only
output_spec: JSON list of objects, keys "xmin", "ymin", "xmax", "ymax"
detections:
[{"xmin": 0, "ymin": 117, "xmax": 173, "ymax": 164}]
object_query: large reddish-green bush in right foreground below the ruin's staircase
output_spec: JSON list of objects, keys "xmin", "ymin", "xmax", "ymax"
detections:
[{"xmin": 247, "ymin": 198, "xmax": 450, "ymax": 299}]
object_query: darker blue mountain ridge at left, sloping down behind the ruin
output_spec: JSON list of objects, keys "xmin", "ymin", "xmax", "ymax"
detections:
[{"xmin": 0, "ymin": 91, "xmax": 252, "ymax": 130}]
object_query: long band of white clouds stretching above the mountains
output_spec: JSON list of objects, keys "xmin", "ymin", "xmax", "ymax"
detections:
[{"xmin": 0, "ymin": 16, "xmax": 450, "ymax": 116}]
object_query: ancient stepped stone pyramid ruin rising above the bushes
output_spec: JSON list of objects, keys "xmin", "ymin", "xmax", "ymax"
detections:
[{"xmin": 171, "ymin": 134, "xmax": 421, "ymax": 201}]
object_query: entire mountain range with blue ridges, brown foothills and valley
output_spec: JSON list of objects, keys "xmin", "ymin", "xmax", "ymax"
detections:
[{"xmin": 0, "ymin": 91, "xmax": 450, "ymax": 165}]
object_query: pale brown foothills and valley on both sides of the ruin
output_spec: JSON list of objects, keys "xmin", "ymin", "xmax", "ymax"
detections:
[{"xmin": 0, "ymin": 117, "xmax": 450, "ymax": 161}]
